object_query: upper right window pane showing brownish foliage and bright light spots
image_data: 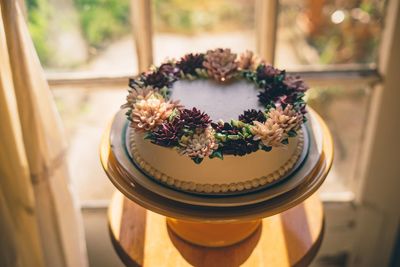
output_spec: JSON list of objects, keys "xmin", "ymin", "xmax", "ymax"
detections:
[{"xmin": 277, "ymin": 0, "xmax": 385, "ymax": 68}]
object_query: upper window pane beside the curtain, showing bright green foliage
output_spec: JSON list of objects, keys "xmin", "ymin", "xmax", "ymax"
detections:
[{"xmin": 26, "ymin": 0, "xmax": 136, "ymax": 72}]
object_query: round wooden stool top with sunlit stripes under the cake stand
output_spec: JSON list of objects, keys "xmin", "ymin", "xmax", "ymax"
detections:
[{"xmin": 108, "ymin": 192, "xmax": 324, "ymax": 267}]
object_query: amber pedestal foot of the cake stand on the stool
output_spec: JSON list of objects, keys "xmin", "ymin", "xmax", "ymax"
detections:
[{"xmin": 167, "ymin": 218, "xmax": 261, "ymax": 247}]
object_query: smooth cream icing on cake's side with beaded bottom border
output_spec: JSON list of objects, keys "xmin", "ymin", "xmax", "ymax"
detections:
[{"xmin": 129, "ymin": 131, "xmax": 303, "ymax": 193}]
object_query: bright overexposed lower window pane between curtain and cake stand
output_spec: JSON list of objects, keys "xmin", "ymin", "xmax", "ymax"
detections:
[{"xmin": 52, "ymin": 88, "xmax": 127, "ymax": 201}]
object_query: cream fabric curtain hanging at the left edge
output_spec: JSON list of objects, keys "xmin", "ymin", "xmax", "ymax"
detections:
[{"xmin": 0, "ymin": 0, "xmax": 88, "ymax": 267}]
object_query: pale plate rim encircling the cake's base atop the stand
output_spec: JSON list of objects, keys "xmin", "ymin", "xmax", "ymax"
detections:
[{"xmin": 110, "ymin": 112, "xmax": 322, "ymax": 207}]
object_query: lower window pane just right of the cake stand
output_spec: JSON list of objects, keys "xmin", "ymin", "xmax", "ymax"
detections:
[{"xmin": 307, "ymin": 85, "xmax": 371, "ymax": 192}]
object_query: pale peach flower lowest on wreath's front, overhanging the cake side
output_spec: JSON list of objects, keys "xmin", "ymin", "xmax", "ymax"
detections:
[{"xmin": 180, "ymin": 127, "xmax": 218, "ymax": 161}]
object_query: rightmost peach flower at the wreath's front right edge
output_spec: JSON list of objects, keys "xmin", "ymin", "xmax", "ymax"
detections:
[{"xmin": 267, "ymin": 105, "xmax": 303, "ymax": 133}]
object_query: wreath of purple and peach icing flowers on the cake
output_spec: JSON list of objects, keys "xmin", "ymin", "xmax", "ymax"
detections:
[{"xmin": 121, "ymin": 48, "xmax": 308, "ymax": 164}]
